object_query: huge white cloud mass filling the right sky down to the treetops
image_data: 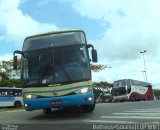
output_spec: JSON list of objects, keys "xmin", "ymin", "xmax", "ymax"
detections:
[{"xmin": 73, "ymin": 0, "xmax": 160, "ymax": 87}]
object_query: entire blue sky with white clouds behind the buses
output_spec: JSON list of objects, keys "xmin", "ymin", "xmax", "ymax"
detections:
[{"xmin": 0, "ymin": 0, "xmax": 160, "ymax": 89}]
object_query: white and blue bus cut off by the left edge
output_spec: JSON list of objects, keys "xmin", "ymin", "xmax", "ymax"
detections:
[{"xmin": 0, "ymin": 87, "xmax": 23, "ymax": 108}]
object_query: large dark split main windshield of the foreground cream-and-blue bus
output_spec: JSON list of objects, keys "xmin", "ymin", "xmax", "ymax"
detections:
[{"xmin": 22, "ymin": 45, "xmax": 91, "ymax": 86}]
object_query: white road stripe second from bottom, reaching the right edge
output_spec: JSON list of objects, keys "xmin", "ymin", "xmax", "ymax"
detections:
[{"xmin": 100, "ymin": 116, "xmax": 160, "ymax": 120}]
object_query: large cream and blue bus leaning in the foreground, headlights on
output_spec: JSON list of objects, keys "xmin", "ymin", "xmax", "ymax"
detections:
[{"xmin": 13, "ymin": 30, "xmax": 97, "ymax": 114}]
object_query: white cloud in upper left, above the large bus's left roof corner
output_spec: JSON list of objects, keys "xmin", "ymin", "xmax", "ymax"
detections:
[{"xmin": 0, "ymin": 0, "xmax": 59, "ymax": 44}]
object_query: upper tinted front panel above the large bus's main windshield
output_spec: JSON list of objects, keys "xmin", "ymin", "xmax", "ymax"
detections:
[{"xmin": 23, "ymin": 30, "xmax": 87, "ymax": 51}]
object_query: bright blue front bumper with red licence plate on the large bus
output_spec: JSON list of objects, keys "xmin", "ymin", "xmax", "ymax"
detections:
[{"xmin": 23, "ymin": 92, "xmax": 94, "ymax": 111}]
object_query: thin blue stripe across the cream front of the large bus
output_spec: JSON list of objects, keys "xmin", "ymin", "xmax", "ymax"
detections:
[{"xmin": 23, "ymin": 85, "xmax": 92, "ymax": 94}]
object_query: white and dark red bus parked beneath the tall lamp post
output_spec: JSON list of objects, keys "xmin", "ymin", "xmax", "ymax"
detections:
[{"xmin": 111, "ymin": 79, "xmax": 154, "ymax": 102}]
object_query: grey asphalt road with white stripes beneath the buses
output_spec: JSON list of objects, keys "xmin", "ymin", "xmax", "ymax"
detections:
[{"xmin": 0, "ymin": 100, "xmax": 160, "ymax": 130}]
